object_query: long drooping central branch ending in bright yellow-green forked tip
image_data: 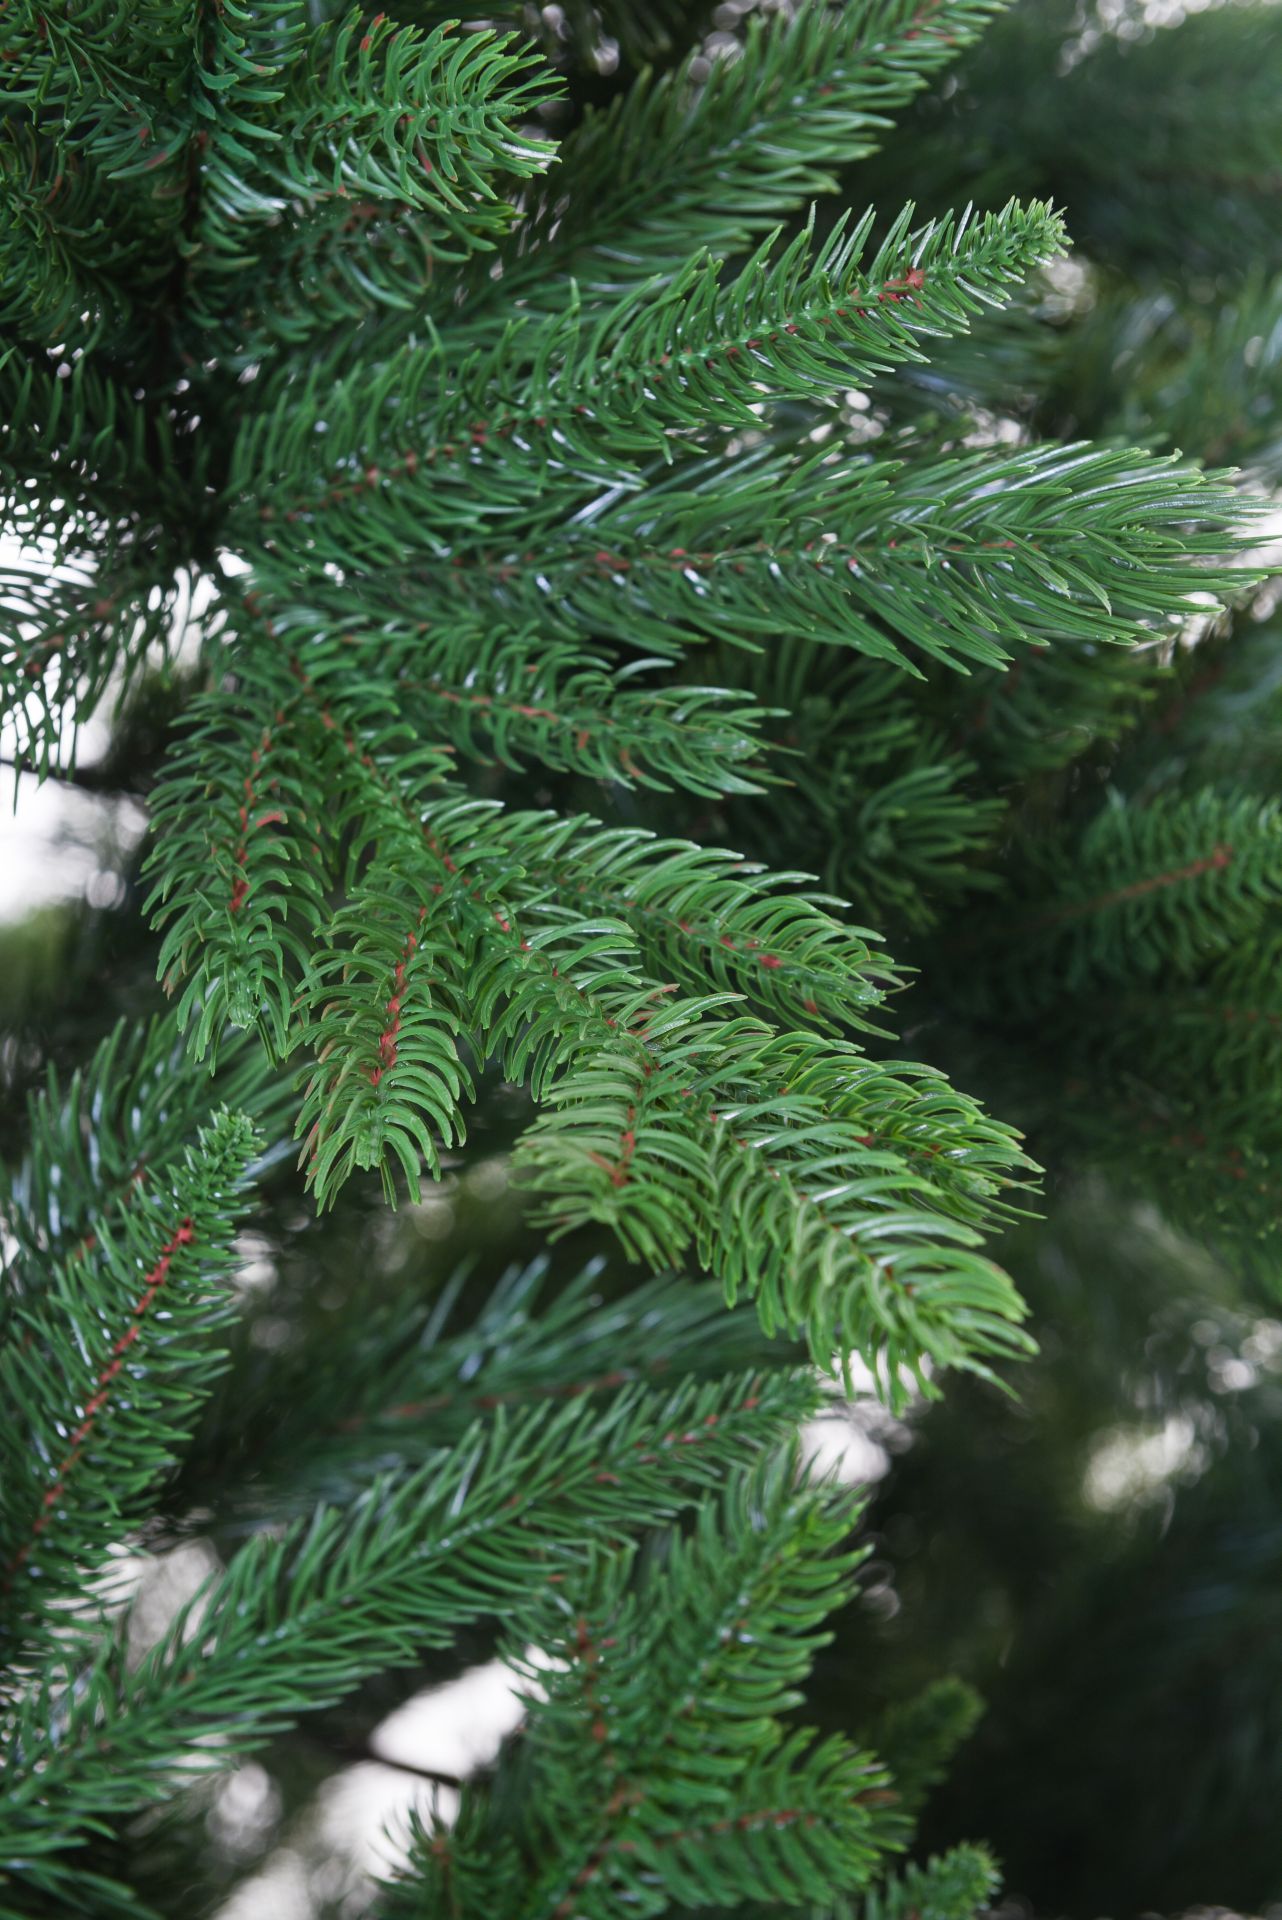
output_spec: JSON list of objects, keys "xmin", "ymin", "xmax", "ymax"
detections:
[{"xmin": 320, "ymin": 779, "xmax": 1021, "ymax": 1396}]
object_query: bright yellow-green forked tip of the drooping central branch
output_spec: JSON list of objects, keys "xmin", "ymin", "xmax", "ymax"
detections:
[{"xmin": 516, "ymin": 1036, "xmax": 1029, "ymax": 1405}]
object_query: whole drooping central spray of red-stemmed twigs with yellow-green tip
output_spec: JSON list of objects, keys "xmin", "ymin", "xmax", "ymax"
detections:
[{"xmin": 135, "ymin": 647, "xmax": 1025, "ymax": 1382}]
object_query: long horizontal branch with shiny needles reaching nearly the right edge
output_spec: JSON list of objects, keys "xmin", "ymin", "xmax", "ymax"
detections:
[{"xmin": 362, "ymin": 445, "xmax": 1251, "ymax": 668}]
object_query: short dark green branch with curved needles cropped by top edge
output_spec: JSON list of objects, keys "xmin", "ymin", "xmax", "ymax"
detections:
[{"xmin": 188, "ymin": 0, "xmax": 553, "ymax": 345}]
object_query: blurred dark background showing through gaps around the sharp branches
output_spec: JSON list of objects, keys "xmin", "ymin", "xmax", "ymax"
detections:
[{"xmin": 0, "ymin": 0, "xmax": 1282, "ymax": 1920}]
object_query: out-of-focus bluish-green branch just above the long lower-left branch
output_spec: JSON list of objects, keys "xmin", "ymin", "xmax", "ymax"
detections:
[{"xmin": 167, "ymin": 1256, "xmax": 798, "ymax": 1524}]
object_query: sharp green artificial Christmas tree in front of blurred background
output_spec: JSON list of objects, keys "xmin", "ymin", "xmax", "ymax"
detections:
[{"xmin": 0, "ymin": 0, "xmax": 1258, "ymax": 1920}]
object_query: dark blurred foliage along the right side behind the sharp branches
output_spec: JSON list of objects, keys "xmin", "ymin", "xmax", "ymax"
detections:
[{"xmin": 767, "ymin": 4, "xmax": 1282, "ymax": 1914}]
